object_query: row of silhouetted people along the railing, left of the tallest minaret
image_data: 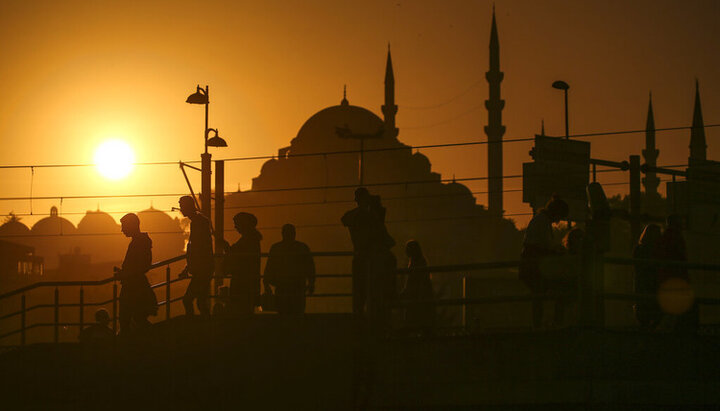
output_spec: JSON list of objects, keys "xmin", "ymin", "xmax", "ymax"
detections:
[{"xmin": 81, "ymin": 188, "xmax": 434, "ymax": 340}]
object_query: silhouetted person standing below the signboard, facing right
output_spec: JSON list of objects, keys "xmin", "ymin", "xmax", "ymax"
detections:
[{"xmin": 519, "ymin": 196, "xmax": 569, "ymax": 328}]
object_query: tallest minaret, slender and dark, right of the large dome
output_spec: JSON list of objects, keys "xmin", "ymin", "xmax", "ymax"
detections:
[{"xmin": 485, "ymin": 5, "xmax": 505, "ymax": 216}]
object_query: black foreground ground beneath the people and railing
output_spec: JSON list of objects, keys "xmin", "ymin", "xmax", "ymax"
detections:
[{"xmin": 0, "ymin": 315, "xmax": 720, "ymax": 410}]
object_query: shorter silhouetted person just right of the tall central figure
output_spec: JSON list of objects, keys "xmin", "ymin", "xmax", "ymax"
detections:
[{"xmin": 401, "ymin": 240, "xmax": 435, "ymax": 334}]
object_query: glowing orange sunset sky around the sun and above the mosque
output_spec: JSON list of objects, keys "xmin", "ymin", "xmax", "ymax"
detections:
[{"xmin": 0, "ymin": 0, "xmax": 720, "ymax": 229}]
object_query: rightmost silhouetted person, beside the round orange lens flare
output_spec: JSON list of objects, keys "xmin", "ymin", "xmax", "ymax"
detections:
[{"xmin": 657, "ymin": 214, "xmax": 700, "ymax": 332}]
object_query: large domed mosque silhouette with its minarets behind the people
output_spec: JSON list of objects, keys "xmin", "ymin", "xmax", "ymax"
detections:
[{"xmin": 224, "ymin": 16, "xmax": 521, "ymax": 320}]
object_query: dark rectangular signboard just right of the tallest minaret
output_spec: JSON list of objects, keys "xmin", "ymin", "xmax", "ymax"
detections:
[{"xmin": 523, "ymin": 135, "xmax": 590, "ymax": 221}]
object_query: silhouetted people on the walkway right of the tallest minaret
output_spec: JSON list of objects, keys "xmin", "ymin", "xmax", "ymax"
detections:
[{"xmin": 519, "ymin": 196, "xmax": 699, "ymax": 331}]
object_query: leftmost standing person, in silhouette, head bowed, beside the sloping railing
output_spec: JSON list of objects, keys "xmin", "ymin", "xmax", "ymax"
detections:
[{"xmin": 115, "ymin": 213, "xmax": 157, "ymax": 335}]
